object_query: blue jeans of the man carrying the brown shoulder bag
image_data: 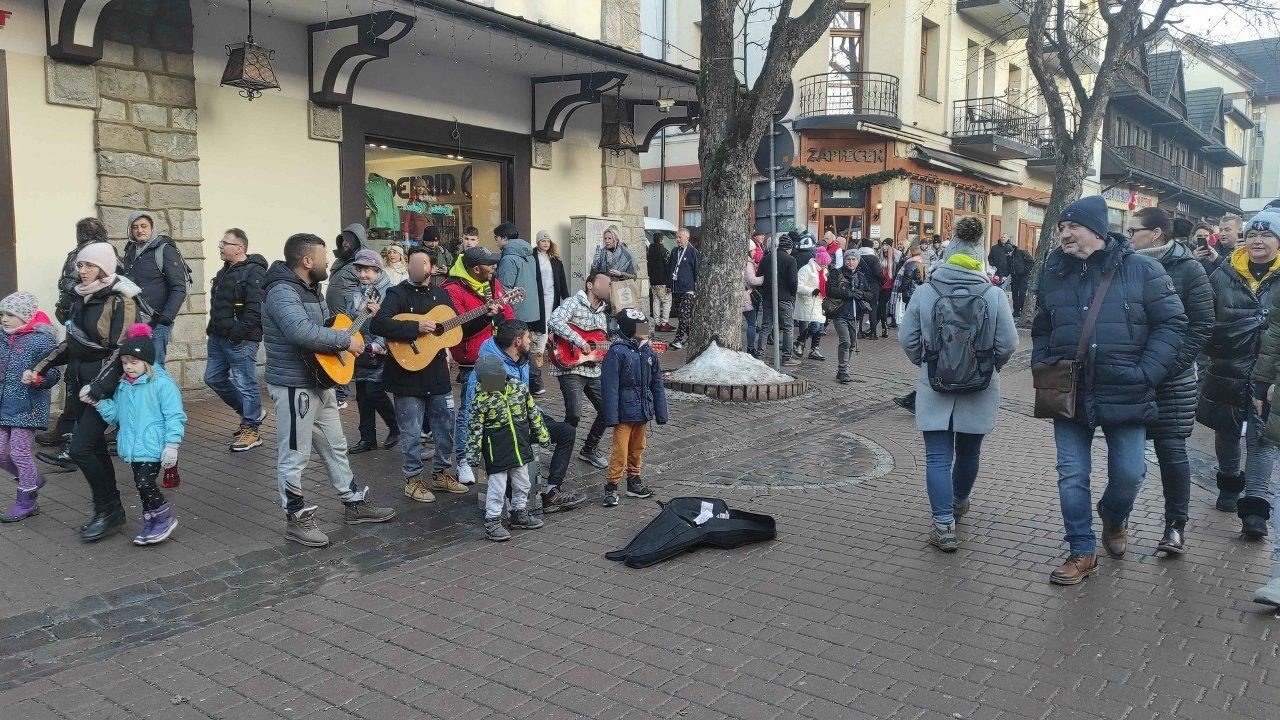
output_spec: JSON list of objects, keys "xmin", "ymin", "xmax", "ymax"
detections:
[{"xmin": 1053, "ymin": 420, "xmax": 1147, "ymax": 555}]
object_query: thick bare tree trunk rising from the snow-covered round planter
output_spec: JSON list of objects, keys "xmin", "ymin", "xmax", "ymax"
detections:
[{"xmin": 681, "ymin": 0, "xmax": 845, "ymax": 357}]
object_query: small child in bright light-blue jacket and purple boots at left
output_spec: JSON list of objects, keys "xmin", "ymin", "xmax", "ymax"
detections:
[{"xmin": 95, "ymin": 324, "xmax": 187, "ymax": 544}]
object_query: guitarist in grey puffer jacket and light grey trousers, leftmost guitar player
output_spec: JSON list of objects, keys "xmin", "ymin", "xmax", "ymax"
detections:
[{"xmin": 262, "ymin": 234, "xmax": 396, "ymax": 547}]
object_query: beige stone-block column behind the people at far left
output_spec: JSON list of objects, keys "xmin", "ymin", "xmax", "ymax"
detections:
[{"xmin": 93, "ymin": 41, "xmax": 206, "ymax": 388}]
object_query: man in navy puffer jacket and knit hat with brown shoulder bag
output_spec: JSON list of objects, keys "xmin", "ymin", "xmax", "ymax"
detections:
[{"xmin": 1032, "ymin": 196, "xmax": 1187, "ymax": 585}]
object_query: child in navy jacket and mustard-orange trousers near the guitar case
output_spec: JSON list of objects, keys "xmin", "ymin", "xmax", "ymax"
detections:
[{"xmin": 600, "ymin": 307, "xmax": 667, "ymax": 507}]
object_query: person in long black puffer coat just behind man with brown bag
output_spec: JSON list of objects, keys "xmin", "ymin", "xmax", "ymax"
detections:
[{"xmin": 1129, "ymin": 208, "xmax": 1213, "ymax": 555}]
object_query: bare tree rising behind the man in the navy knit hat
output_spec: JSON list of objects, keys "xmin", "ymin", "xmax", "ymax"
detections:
[{"xmin": 1023, "ymin": 0, "xmax": 1276, "ymax": 319}]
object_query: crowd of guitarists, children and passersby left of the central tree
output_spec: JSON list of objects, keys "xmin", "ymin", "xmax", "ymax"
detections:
[{"xmin": 0, "ymin": 213, "xmax": 670, "ymax": 547}]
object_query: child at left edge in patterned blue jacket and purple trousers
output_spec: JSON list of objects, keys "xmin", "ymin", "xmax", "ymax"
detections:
[{"xmin": 0, "ymin": 292, "xmax": 60, "ymax": 523}]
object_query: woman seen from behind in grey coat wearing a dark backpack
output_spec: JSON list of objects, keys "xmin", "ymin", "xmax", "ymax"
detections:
[{"xmin": 899, "ymin": 218, "xmax": 1018, "ymax": 552}]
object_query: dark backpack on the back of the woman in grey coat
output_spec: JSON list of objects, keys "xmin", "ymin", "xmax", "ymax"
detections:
[{"xmin": 923, "ymin": 281, "xmax": 996, "ymax": 395}]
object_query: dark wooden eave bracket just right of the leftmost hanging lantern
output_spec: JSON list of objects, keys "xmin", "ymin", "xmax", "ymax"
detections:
[{"xmin": 307, "ymin": 10, "xmax": 413, "ymax": 106}]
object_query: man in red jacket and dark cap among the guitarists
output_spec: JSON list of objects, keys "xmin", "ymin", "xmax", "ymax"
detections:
[{"xmin": 433, "ymin": 247, "xmax": 516, "ymax": 486}]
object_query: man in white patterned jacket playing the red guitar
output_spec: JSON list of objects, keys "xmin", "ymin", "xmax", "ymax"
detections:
[{"xmin": 547, "ymin": 270, "xmax": 613, "ymax": 470}]
